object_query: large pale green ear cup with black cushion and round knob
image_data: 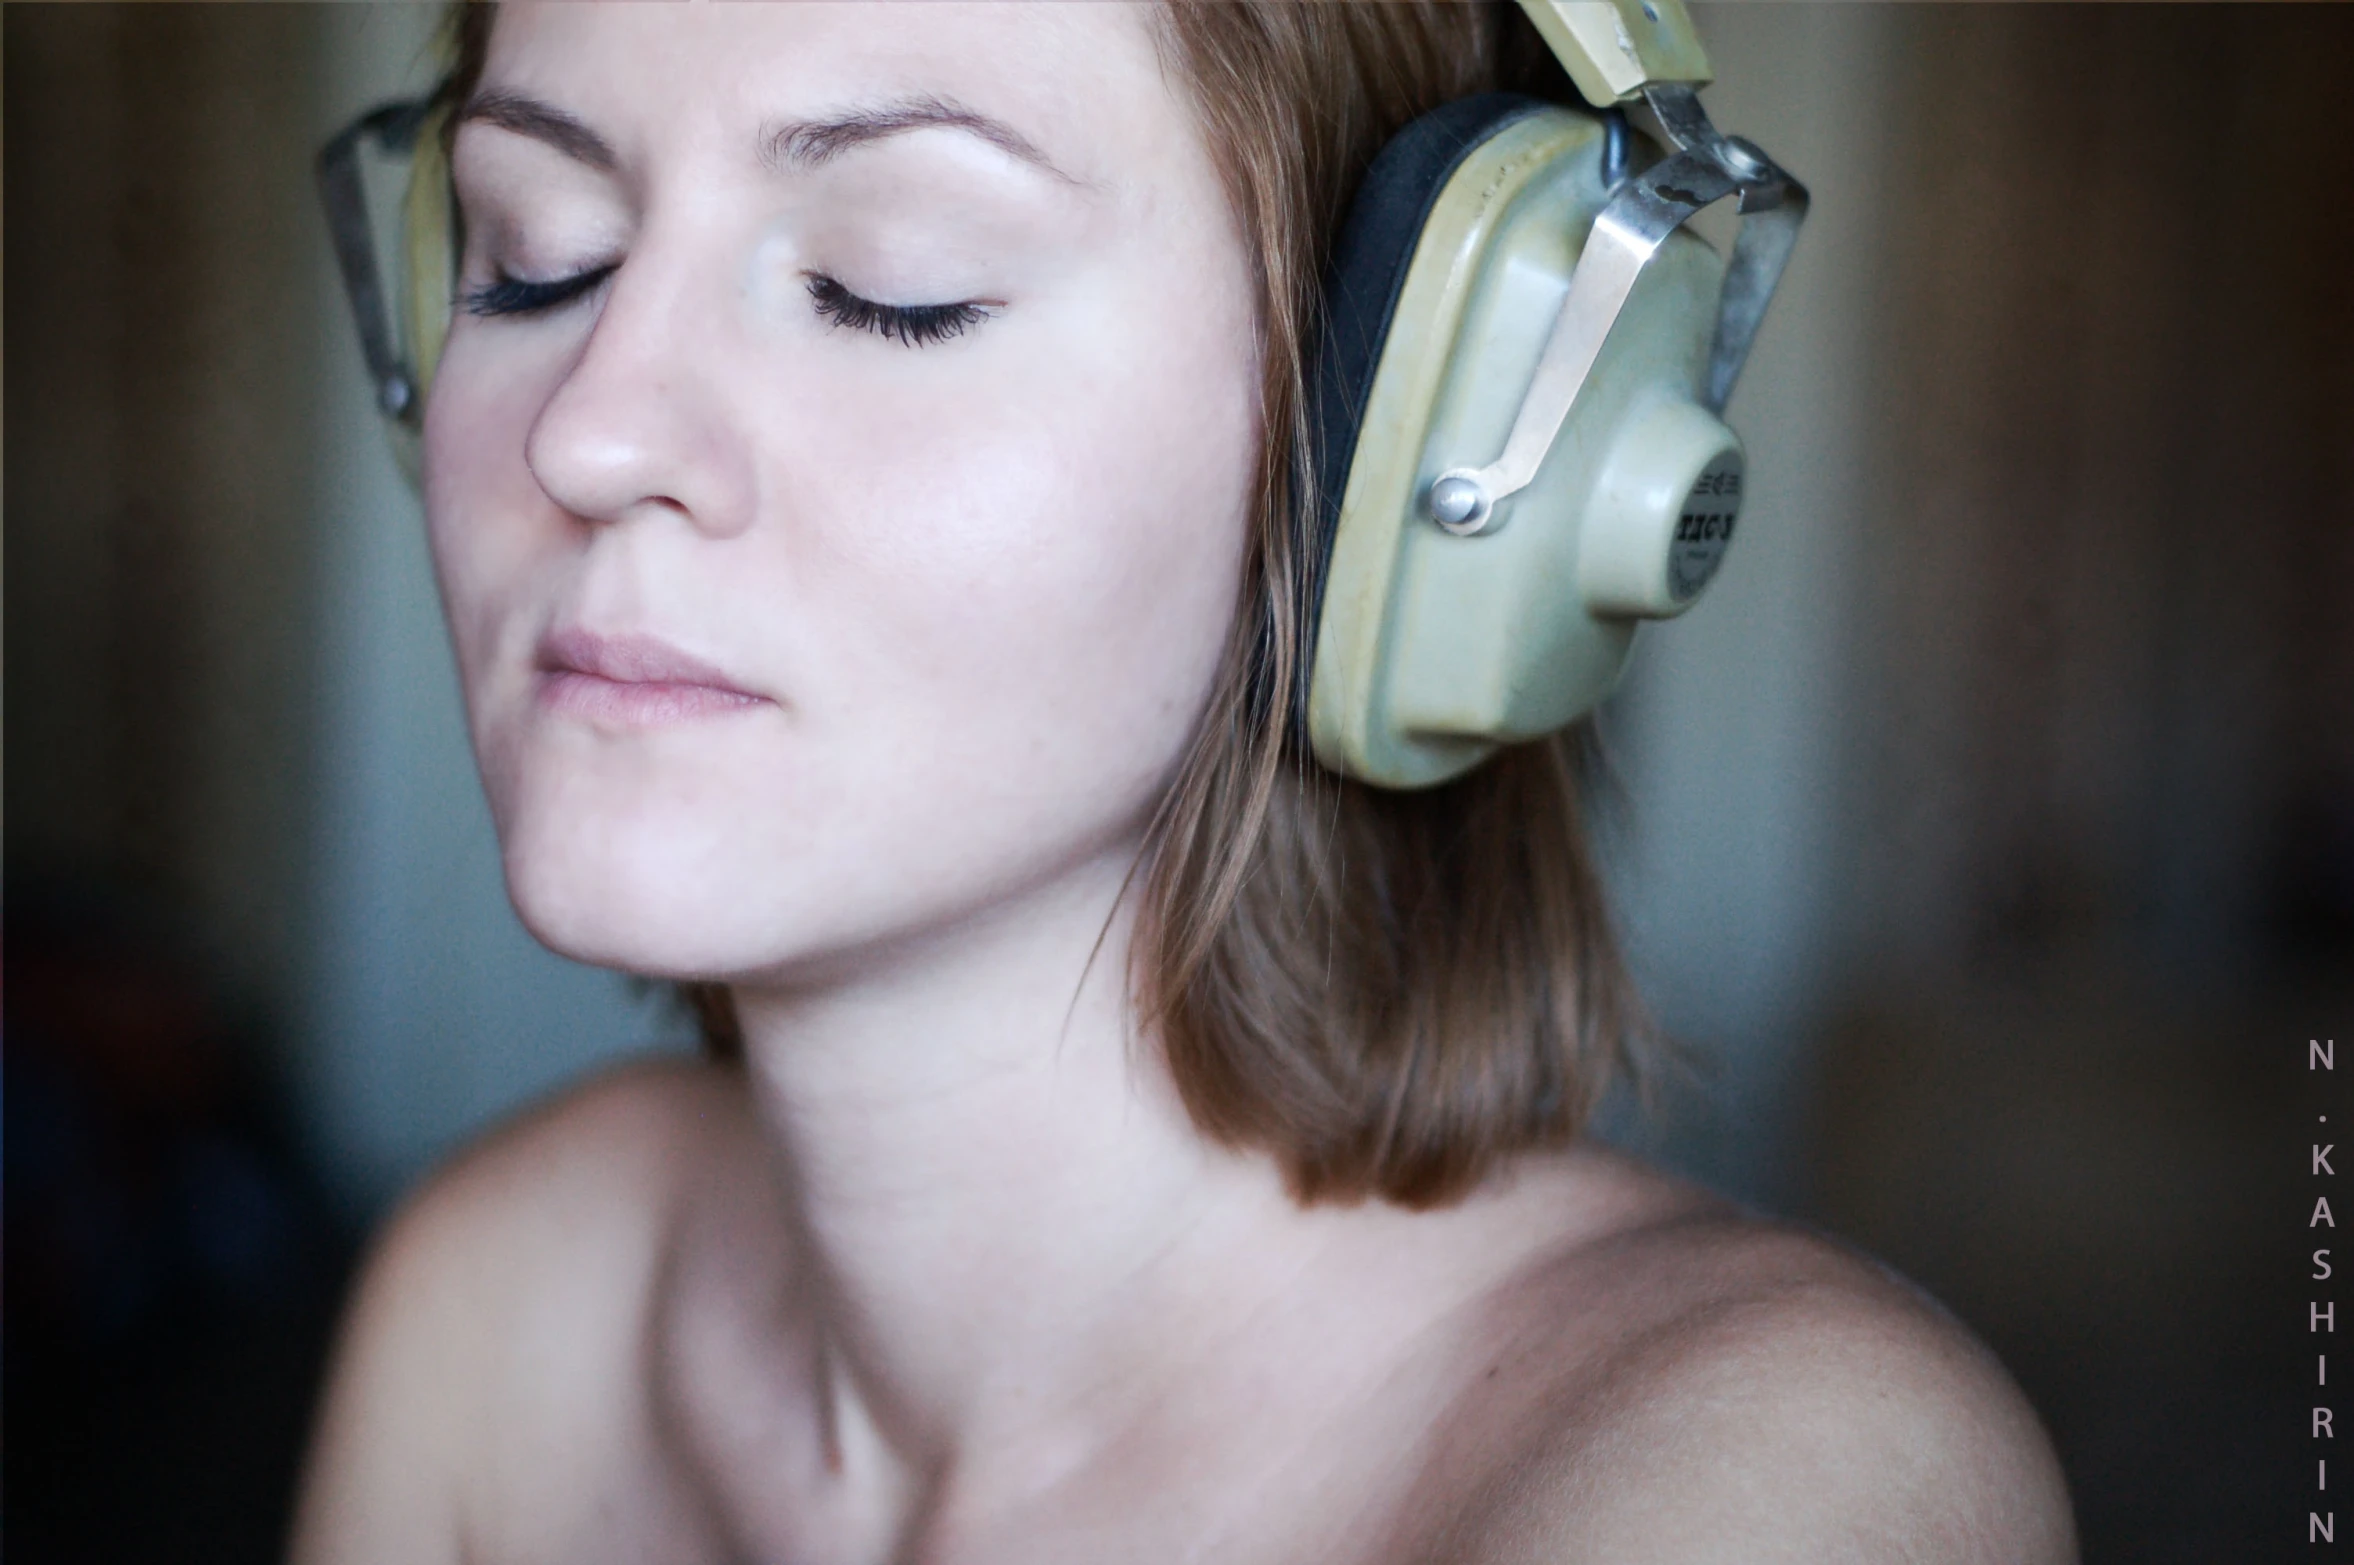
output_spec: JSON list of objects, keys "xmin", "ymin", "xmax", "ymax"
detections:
[{"xmin": 1304, "ymin": 99, "xmax": 1742, "ymax": 788}]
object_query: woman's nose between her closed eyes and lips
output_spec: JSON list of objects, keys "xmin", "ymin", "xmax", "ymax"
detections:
[{"xmin": 523, "ymin": 252, "xmax": 753, "ymax": 537}]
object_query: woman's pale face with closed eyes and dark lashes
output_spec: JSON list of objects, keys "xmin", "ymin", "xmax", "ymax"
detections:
[{"xmin": 426, "ymin": 2, "xmax": 1259, "ymax": 977}]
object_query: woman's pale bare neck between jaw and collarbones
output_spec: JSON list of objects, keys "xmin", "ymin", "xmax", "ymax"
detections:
[{"xmin": 737, "ymin": 861, "xmax": 1314, "ymax": 1480}]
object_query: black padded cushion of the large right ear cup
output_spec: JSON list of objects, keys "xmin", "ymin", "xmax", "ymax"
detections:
[{"xmin": 1295, "ymin": 92, "xmax": 1547, "ymax": 746}]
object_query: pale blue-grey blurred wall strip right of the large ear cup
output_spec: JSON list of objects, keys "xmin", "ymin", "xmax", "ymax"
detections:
[{"xmin": 1603, "ymin": 5, "xmax": 1900, "ymax": 1203}]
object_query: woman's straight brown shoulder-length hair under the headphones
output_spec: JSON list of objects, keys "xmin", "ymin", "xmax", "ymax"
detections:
[{"xmin": 428, "ymin": 0, "xmax": 1638, "ymax": 1207}]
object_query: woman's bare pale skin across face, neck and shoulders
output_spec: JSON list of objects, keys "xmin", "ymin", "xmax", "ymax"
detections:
[{"xmin": 294, "ymin": 2, "xmax": 2074, "ymax": 1565}]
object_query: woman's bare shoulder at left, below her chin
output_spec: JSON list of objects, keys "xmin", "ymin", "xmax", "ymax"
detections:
[{"xmin": 294, "ymin": 1061, "xmax": 753, "ymax": 1563}]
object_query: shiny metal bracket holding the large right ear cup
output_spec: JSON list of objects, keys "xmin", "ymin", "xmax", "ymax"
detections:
[{"xmin": 1424, "ymin": 82, "xmax": 1808, "ymax": 534}]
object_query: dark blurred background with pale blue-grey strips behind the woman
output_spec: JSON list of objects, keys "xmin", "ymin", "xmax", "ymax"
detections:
[{"xmin": 0, "ymin": 5, "xmax": 2354, "ymax": 1565}]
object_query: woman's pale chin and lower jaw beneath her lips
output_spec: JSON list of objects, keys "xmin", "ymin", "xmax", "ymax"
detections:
[{"xmin": 483, "ymin": 682, "xmax": 1175, "ymax": 984}]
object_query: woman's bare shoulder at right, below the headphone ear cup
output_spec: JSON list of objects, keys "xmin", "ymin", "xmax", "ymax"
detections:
[{"xmin": 1431, "ymin": 1160, "xmax": 2076, "ymax": 1565}]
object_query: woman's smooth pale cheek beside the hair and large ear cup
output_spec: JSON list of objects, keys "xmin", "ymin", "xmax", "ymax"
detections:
[{"xmin": 800, "ymin": 273, "xmax": 1257, "ymax": 793}]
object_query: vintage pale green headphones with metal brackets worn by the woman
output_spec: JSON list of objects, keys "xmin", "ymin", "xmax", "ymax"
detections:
[{"xmin": 320, "ymin": 0, "xmax": 1806, "ymax": 788}]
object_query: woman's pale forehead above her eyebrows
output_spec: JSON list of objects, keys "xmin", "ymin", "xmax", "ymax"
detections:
[{"xmin": 483, "ymin": 0, "xmax": 1198, "ymax": 184}]
